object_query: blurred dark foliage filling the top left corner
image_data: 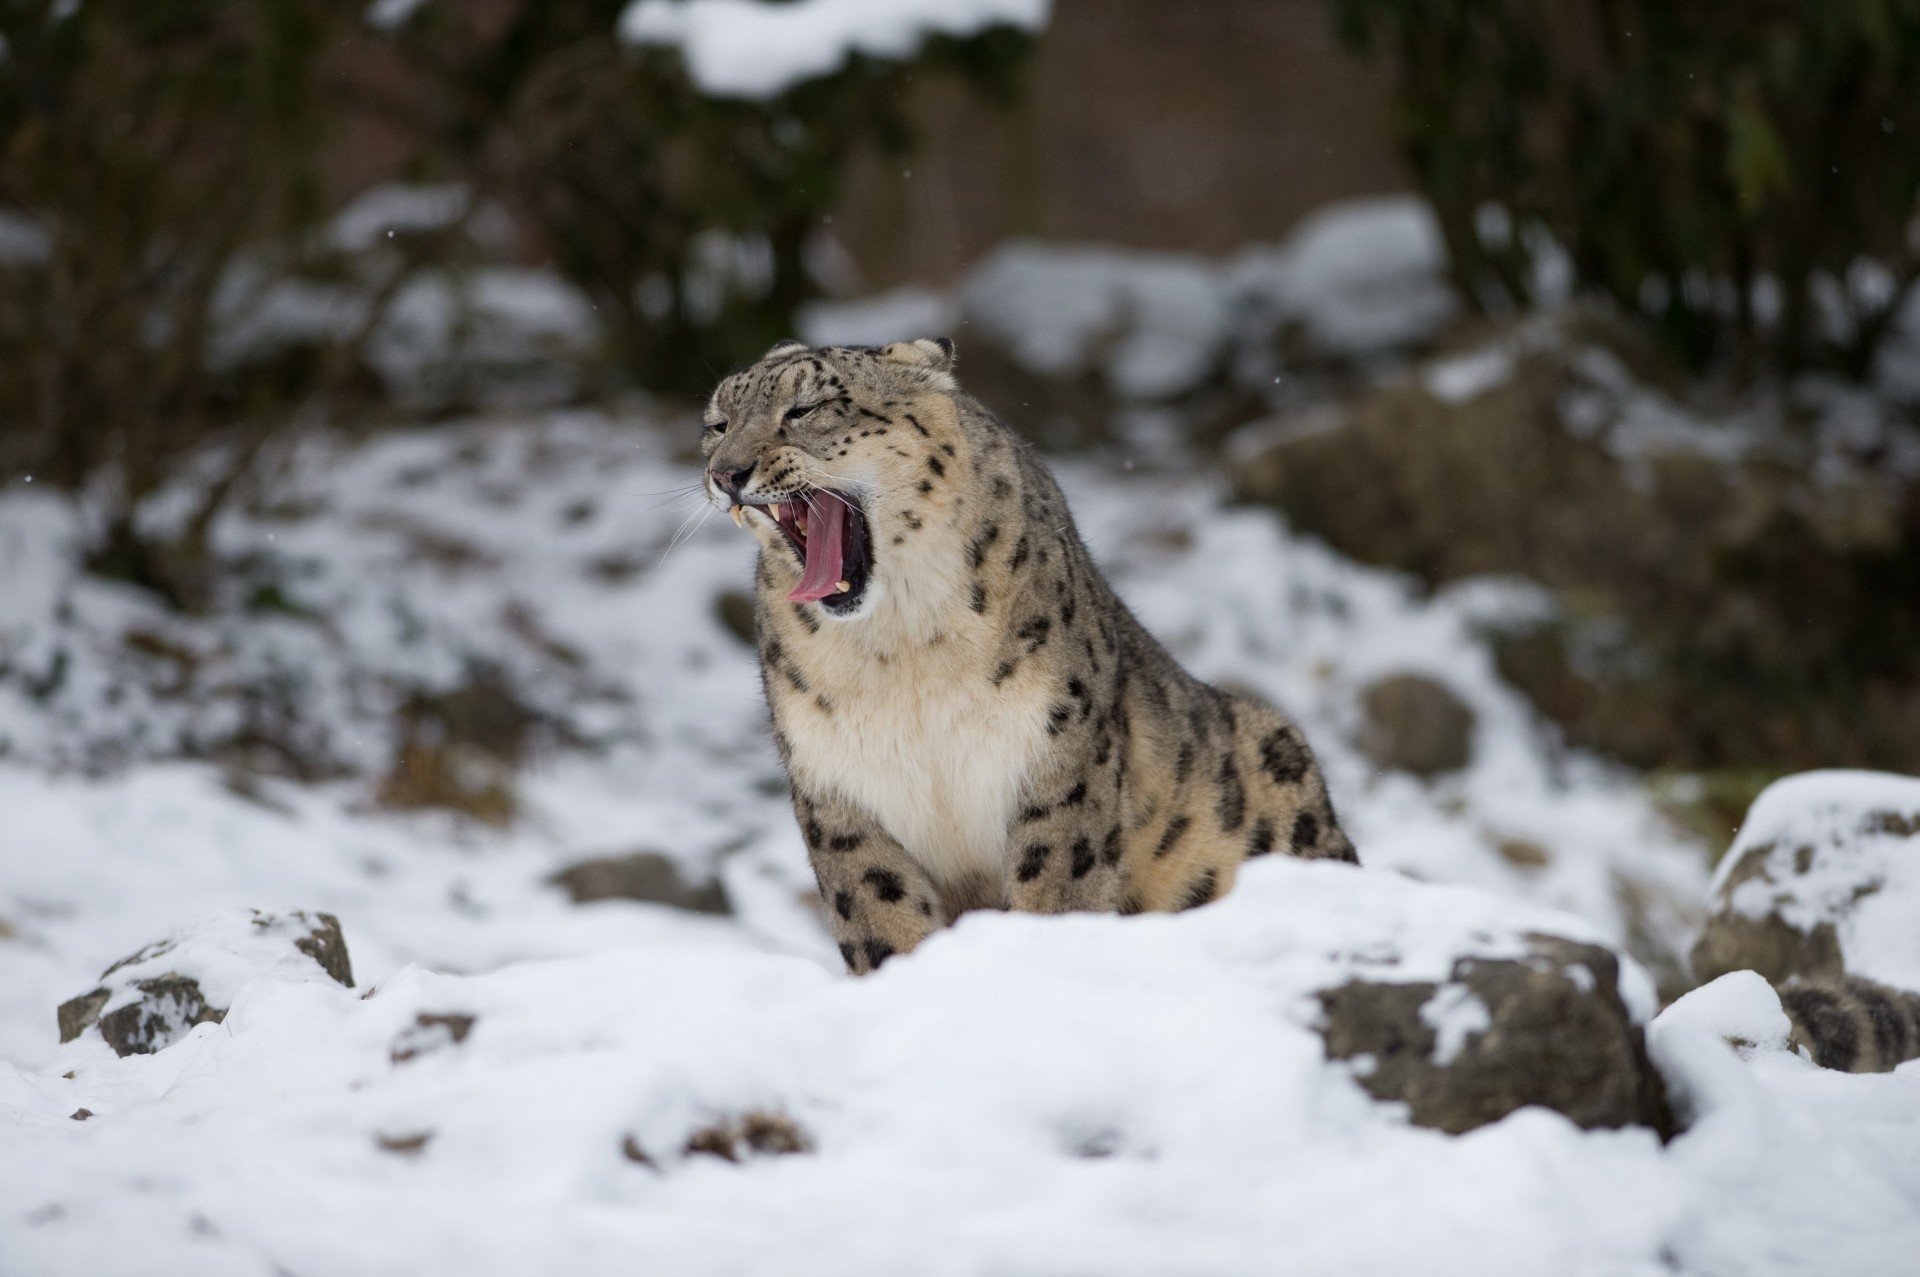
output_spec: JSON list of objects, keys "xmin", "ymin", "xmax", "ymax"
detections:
[{"xmin": 0, "ymin": 0, "xmax": 357, "ymax": 583}]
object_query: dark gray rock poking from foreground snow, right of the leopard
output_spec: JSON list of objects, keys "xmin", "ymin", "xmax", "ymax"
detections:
[{"xmin": 1319, "ymin": 935, "xmax": 1674, "ymax": 1139}]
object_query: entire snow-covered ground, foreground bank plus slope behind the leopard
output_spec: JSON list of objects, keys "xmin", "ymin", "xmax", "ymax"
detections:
[{"xmin": 0, "ymin": 413, "xmax": 1920, "ymax": 1275}]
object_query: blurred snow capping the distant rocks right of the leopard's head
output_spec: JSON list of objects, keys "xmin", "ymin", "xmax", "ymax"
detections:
[{"xmin": 801, "ymin": 196, "xmax": 1451, "ymax": 403}]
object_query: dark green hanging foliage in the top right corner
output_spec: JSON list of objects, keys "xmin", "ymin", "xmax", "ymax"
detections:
[{"xmin": 1331, "ymin": 0, "xmax": 1920, "ymax": 376}]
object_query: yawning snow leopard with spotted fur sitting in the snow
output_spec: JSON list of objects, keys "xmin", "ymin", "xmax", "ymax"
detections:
[{"xmin": 703, "ymin": 340, "xmax": 1356, "ymax": 974}]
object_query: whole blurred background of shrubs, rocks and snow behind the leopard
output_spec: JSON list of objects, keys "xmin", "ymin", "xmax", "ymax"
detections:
[{"xmin": 0, "ymin": 0, "xmax": 1920, "ymax": 1062}]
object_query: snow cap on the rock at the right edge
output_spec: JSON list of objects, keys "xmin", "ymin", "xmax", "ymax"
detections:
[{"xmin": 1713, "ymin": 770, "xmax": 1920, "ymax": 989}]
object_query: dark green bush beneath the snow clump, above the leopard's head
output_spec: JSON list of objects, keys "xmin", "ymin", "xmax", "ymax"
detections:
[{"xmin": 351, "ymin": 0, "xmax": 1031, "ymax": 394}]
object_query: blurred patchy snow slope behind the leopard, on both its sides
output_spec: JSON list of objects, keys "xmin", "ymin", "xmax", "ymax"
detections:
[{"xmin": 0, "ymin": 415, "xmax": 1709, "ymax": 1064}]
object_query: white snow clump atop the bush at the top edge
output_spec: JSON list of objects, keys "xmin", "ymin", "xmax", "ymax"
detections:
[{"xmin": 620, "ymin": 0, "xmax": 1052, "ymax": 98}]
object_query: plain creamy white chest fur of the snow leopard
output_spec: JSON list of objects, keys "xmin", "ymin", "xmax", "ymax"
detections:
[{"xmin": 780, "ymin": 630, "xmax": 1046, "ymax": 885}]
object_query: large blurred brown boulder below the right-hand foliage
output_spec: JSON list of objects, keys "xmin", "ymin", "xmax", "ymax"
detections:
[{"xmin": 1229, "ymin": 311, "xmax": 1920, "ymax": 772}]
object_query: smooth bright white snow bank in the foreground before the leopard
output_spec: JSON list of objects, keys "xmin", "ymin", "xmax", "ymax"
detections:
[{"xmin": 15, "ymin": 858, "xmax": 1920, "ymax": 1275}]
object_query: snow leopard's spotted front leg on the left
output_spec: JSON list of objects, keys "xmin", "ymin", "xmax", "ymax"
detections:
[{"xmin": 793, "ymin": 785, "xmax": 945, "ymax": 976}]
